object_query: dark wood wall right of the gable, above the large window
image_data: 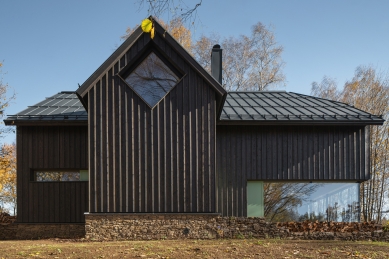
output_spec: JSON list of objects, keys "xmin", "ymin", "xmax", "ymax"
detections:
[{"xmin": 216, "ymin": 126, "xmax": 370, "ymax": 216}]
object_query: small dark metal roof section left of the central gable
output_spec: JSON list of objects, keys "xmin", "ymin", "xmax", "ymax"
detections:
[{"xmin": 4, "ymin": 91, "xmax": 88, "ymax": 125}]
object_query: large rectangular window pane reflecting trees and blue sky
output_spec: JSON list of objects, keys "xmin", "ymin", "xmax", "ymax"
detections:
[{"xmin": 264, "ymin": 183, "xmax": 360, "ymax": 222}]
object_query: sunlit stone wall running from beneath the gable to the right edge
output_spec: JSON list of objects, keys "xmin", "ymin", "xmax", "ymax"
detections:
[{"xmin": 85, "ymin": 214, "xmax": 389, "ymax": 242}]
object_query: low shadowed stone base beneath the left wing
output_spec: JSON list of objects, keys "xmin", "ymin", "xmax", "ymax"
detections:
[{"xmin": 0, "ymin": 223, "xmax": 85, "ymax": 240}]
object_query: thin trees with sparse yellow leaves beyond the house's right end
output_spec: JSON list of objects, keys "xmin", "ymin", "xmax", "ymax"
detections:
[{"xmin": 311, "ymin": 66, "xmax": 389, "ymax": 222}]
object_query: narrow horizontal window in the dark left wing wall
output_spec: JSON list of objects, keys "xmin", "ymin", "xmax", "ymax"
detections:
[{"xmin": 33, "ymin": 170, "xmax": 88, "ymax": 182}]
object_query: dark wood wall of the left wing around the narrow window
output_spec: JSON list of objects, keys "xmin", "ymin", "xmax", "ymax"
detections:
[{"xmin": 16, "ymin": 126, "xmax": 88, "ymax": 223}]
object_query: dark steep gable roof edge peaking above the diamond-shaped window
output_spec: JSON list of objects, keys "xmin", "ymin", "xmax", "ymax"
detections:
[{"xmin": 76, "ymin": 16, "xmax": 227, "ymax": 114}]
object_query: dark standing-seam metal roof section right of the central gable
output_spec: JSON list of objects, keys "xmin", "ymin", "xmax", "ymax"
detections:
[{"xmin": 218, "ymin": 91, "xmax": 384, "ymax": 125}]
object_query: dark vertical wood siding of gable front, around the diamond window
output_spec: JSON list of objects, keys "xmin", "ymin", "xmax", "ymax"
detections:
[{"xmin": 88, "ymin": 34, "xmax": 216, "ymax": 212}]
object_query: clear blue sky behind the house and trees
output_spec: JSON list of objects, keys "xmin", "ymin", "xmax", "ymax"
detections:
[{"xmin": 0, "ymin": 0, "xmax": 389, "ymax": 143}]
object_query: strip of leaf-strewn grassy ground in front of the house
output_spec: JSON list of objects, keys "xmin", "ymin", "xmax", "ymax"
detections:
[{"xmin": 0, "ymin": 239, "xmax": 389, "ymax": 259}]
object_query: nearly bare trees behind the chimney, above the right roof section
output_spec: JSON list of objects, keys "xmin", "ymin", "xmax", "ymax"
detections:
[{"xmin": 192, "ymin": 22, "xmax": 285, "ymax": 91}]
